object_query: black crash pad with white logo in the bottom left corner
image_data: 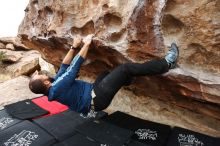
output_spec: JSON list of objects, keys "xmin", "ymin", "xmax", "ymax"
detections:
[{"xmin": 0, "ymin": 121, "xmax": 55, "ymax": 146}]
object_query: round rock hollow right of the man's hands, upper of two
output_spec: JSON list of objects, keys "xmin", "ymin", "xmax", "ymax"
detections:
[{"xmin": 104, "ymin": 14, "xmax": 122, "ymax": 31}]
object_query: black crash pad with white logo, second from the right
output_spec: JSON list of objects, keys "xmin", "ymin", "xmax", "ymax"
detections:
[{"xmin": 102, "ymin": 111, "xmax": 171, "ymax": 146}]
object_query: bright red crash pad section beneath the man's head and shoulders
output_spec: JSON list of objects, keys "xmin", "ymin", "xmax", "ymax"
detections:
[{"xmin": 32, "ymin": 96, "xmax": 69, "ymax": 117}]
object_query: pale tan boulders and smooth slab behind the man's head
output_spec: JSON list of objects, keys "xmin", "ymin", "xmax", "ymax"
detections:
[{"xmin": 0, "ymin": 37, "xmax": 54, "ymax": 109}]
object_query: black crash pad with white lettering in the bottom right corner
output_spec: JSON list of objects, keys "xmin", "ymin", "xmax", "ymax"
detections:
[{"xmin": 167, "ymin": 127, "xmax": 220, "ymax": 146}]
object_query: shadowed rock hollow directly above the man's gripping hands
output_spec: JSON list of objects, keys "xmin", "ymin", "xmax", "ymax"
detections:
[{"xmin": 71, "ymin": 21, "xmax": 95, "ymax": 36}]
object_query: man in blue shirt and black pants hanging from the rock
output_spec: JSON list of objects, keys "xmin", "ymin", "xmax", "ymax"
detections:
[{"xmin": 29, "ymin": 36, "xmax": 179, "ymax": 113}]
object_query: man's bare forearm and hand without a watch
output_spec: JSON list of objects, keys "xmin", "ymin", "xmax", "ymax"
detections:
[{"xmin": 78, "ymin": 35, "xmax": 93, "ymax": 59}]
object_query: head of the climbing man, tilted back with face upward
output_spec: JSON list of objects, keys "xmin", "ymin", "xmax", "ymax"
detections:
[{"xmin": 29, "ymin": 71, "xmax": 54, "ymax": 95}]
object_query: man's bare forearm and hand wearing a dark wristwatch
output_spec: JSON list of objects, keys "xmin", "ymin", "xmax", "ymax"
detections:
[{"xmin": 62, "ymin": 36, "xmax": 82, "ymax": 64}]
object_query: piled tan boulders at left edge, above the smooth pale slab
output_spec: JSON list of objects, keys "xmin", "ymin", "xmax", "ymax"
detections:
[{"xmin": 0, "ymin": 37, "xmax": 40, "ymax": 82}]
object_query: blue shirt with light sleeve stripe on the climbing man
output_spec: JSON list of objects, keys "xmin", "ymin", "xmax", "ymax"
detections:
[{"xmin": 48, "ymin": 55, "xmax": 93, "ymax": 113}]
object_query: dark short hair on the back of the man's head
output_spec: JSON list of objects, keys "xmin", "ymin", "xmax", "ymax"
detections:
[{"xmin": 29, "ymin": 77, "xmax": 48, "ymax": 95}]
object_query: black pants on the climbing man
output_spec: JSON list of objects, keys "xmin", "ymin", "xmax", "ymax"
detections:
[{"xmin": 94, "ymin": 59, "xmax": 169, "ymax": 111}]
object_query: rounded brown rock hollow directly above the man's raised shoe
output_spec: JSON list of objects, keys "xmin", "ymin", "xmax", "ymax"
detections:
[{"xmin": 162, "ymin": 15, "xmax": 185, "ymax": 35}]
